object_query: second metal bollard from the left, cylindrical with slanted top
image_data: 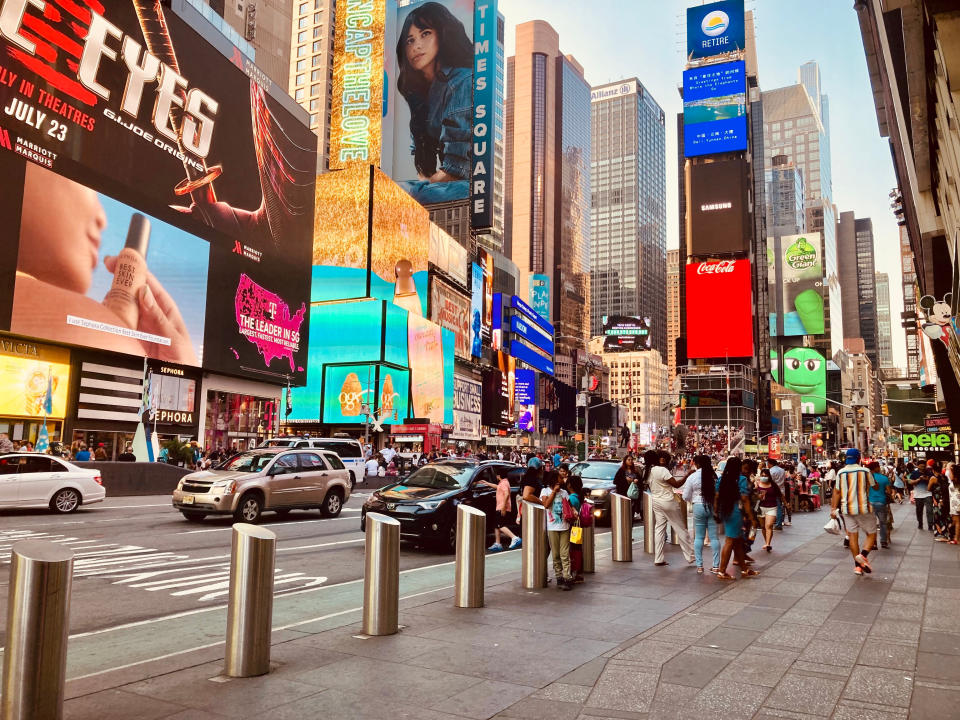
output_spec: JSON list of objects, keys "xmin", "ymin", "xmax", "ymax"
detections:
[{"xmin": 223, "ymin": 523, "xmax": 277, "ymax": 677}]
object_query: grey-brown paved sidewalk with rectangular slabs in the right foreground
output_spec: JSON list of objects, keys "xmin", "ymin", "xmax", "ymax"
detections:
[{"xmin": 65, "ymin": 505, "xmax": 960, "ymax": 720}]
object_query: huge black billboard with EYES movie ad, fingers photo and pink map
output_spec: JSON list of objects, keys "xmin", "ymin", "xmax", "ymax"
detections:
[{"xmin": 0, "ymin": 0, "xmax": 316, "ymax": 384}]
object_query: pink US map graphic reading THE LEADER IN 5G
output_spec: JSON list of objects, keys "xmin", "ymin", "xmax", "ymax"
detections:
[{"xmin": 234, "ymin": 273, "xmax": 307, "ymax": 371}]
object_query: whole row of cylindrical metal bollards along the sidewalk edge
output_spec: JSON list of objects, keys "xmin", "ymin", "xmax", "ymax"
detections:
[{"xmin": 0, "ymin": 494, "xmax": 632, "ymax": 720}]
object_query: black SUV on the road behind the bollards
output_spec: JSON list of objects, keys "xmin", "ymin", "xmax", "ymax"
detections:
[{"xmin": 360, "ymin": 459, "xmax": 523, "ymax": 552}]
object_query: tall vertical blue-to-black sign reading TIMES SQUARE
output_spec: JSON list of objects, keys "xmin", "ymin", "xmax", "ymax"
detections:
[{"xmin": 470, "ymin": 0, "xmax": 497, "ymax": 231}]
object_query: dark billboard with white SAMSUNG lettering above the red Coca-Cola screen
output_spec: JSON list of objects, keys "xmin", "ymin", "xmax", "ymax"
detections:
[{"xmin": 687, "ymin": 158, "xmax": 753, "ymax": 256}]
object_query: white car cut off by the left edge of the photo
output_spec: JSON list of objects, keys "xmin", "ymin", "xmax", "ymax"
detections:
[{"xmin": 0, "ymin": 453, "xmax": 107, "ymax": 513}]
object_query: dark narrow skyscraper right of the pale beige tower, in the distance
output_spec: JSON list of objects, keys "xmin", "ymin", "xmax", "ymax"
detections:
[{"xmin": 837, "ymin": 212, "xmax": 876, "ymax": 368}]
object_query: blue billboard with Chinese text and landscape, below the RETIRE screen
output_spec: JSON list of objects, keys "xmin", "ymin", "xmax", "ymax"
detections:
[{"xmin": 683, "ymin": 61, "xmax": 747, "ymax": 157}]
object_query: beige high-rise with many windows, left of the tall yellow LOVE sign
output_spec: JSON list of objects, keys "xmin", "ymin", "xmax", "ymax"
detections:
[{"xmin": 286, "ymin": 0, "xmax": 335, "ymax": 172}]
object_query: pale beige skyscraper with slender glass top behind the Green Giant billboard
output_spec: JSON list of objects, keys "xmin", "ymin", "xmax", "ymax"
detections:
[{"xmin": 762, "ymin": 63, "xmax": 844, "ymax": 357}]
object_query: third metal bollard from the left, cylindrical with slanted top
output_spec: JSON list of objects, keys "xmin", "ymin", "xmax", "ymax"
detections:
[{"xmin": 363, "ymin": 513, "xmax": 400, "ymax": 635}]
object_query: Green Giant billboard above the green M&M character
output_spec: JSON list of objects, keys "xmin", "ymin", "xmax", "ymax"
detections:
[{"xmin": 767, "ymin": 233, "xmax": 825, "ymax": 337}]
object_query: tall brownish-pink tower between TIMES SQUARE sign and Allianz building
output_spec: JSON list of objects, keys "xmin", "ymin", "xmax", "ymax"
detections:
[{"xmin": 504, "ymin": 20, "xmax": 591, "ymax": 382}]
